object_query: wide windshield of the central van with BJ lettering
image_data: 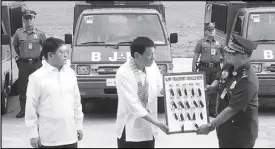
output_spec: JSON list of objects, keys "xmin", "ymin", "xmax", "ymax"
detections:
[{"xmin": 76, "ymin": 14, "xmax": 166, "ymax": 45}]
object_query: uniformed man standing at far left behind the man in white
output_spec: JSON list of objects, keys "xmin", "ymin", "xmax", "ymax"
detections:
[{"xmin": 13, "ymin": 9, "xmax": 46, "ymax": 118}]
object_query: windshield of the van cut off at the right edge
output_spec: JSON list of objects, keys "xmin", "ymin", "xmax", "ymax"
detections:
[{"xmin": 247, "ymin": 12, "xmax": 275, "ymax": 42}]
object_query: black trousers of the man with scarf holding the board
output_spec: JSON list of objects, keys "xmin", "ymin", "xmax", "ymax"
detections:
[{"xmin": 117, "ymin": 128, "xmax": 155, "ymax": 148}]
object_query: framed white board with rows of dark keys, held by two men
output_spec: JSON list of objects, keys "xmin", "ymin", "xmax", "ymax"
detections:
[{"xmin": 163, "ymin": 72, "xmax": 209, "ymax": 134}]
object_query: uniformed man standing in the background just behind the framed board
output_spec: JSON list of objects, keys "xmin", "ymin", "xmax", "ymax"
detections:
[{"xmin": 192, "ymin": 23, "xmax": 223, "ymax": 117}]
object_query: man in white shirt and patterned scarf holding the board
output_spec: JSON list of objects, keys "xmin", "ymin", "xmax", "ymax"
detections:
[{"xmin": 116, "ymin": 37, "xmax": 169, "ymax": 148}]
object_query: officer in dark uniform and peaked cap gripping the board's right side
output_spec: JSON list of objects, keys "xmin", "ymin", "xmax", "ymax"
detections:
[{"xmin": 197, "ymin": 35, "xmax": 259, "ymax": 148}]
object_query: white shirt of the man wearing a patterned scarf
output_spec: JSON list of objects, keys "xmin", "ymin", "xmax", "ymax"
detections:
[{"xmin": 116, "ymin": 61, "xmax": 162, "ymax": 142}]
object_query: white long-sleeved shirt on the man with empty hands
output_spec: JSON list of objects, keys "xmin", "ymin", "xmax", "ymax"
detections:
[{"xmin": 25, "ymin": 62, "xmax": 83, "ymax": 146}]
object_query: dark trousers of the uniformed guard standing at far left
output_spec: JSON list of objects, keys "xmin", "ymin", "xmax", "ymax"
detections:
[{"xmin": 18, "ymin": 61, "xmax": 42, "ymax": 111}]
